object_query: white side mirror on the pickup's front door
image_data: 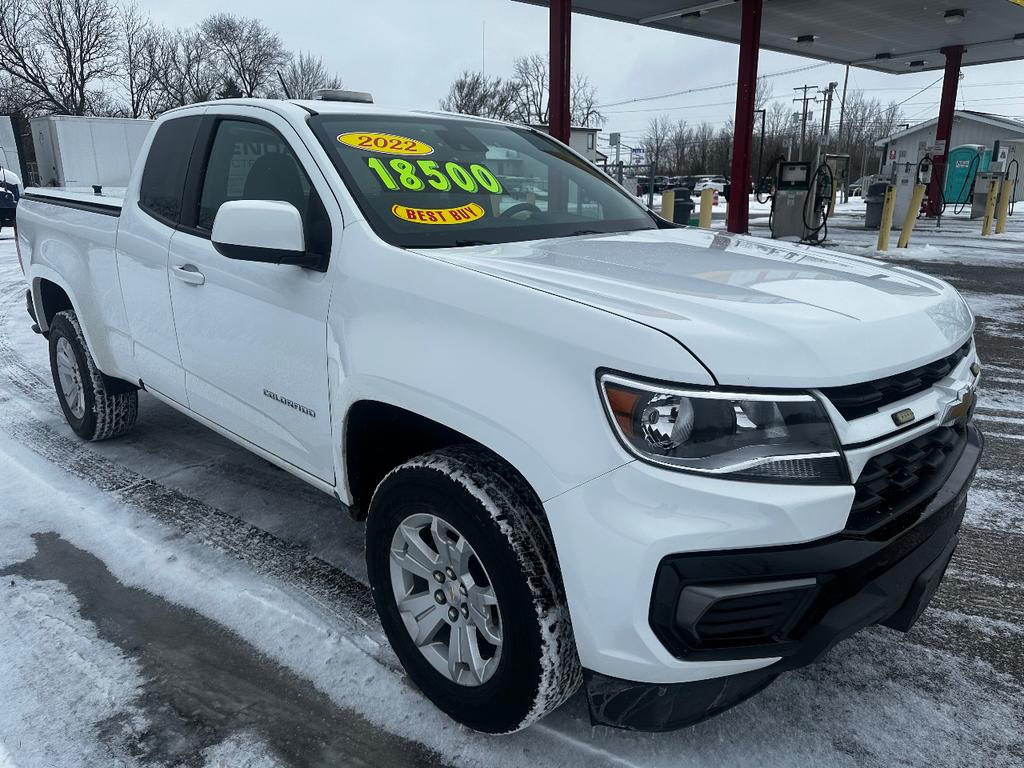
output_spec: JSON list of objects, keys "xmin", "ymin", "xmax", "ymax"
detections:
[{"xmin": 210, "ymin": 200, "xmax": 323, "ymax": 269}]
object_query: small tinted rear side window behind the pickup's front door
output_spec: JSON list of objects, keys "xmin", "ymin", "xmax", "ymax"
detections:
[{"xmin": 138, "ymin": 115, "xmax": 203, "ymax": 226}]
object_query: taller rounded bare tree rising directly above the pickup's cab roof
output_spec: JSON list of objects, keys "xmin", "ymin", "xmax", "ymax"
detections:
[{"xmin": 201, "ymin": 13, "xmax": 288, "ymax": 96}]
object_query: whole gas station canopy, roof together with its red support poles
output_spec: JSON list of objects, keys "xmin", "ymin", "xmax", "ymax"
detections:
[{"xmin": 516, "ymin": 0, "xmax": 1024, "ymax": 232}]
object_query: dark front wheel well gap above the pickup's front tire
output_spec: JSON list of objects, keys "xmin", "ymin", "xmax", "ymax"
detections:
[{"xmin": 344, "ymin": 400, "xmax": 493, "ymax": 520}]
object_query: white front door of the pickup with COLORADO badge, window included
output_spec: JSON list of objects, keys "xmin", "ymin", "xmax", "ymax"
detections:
[{"xmin": 168, "ymin": 108, "xmax": 342, "ymax": 482}]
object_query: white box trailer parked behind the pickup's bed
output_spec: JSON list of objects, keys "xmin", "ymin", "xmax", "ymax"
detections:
[{"xmin": 30, "ymin": 115, "xmax": 153, "ymax": 186}]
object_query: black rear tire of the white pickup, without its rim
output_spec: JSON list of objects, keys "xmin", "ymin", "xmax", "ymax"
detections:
[{"xmin": 49, "ymin": 309, "xmax": 138, "ymax": 440}]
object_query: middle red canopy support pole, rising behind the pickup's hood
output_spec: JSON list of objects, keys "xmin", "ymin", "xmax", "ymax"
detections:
[{"xmin": 726, "ymin": 0, "xmax": 762, "ymax": 232}]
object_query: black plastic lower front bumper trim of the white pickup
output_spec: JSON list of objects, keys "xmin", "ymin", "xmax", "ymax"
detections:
[{"xmin": 585, "ymin": 426, "xmax": 984, "ymax": 730}]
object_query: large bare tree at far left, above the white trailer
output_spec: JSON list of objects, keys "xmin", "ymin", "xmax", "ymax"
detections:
[{"xmin": 0, "ymin": 0, "xmax": 118, "ymax": 115}]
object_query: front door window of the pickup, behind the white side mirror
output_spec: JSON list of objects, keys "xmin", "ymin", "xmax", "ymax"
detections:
[{"xmin": 196, "ymin": 120, "xmax": 331, "ymax": 255}]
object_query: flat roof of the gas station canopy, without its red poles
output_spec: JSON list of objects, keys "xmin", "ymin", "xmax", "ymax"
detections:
[{"xmin": 517, "ymin": 0, "xmax": 1024, "ymax": 74}]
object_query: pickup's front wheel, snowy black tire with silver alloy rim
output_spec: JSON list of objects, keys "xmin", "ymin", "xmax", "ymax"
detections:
[{"xmin": 367, "ymin": 446, "xmax": 581, "ymax": 733}]
